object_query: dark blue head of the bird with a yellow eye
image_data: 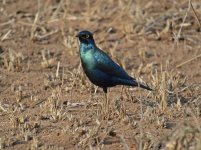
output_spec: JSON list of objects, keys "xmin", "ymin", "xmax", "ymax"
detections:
[{"xmin": 76, "ymin": 31, "xmax": 95, "ymax": 44}]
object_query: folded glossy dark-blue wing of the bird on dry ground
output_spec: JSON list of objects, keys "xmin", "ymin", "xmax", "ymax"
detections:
[{"xmin": 94, "ymin": 50, "xmax": 132, "ymax": 79}]
